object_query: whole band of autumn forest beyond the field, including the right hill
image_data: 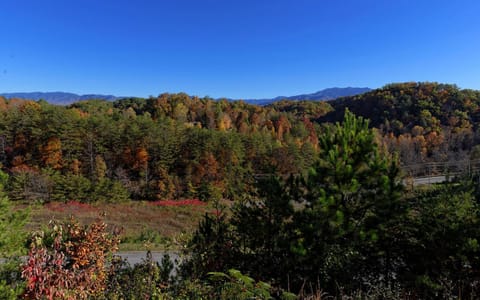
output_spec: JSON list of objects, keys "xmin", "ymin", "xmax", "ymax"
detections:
[{"xmin": 0, "ymin": 83, "xmax": 480, "ymax": 201}]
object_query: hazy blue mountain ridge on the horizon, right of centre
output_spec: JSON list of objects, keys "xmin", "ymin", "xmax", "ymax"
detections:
[{"xmin": 245, "ymin": 87, "xmax": 372, "ymax": 105}]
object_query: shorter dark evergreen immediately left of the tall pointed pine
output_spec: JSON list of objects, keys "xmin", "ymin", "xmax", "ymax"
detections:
[{"xmin": 231, "ymin": 176, "xmax": 299, "ymax": 286}]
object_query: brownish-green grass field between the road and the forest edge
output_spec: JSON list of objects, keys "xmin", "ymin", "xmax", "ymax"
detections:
[{"xmin": 27, "ymin": 200, "xmax": 213, "ymax": 250}]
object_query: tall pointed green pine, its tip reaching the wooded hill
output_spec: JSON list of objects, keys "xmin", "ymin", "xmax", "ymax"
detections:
[{"xmin": 292, "ymin": 110, "xmax": 403, "ymax": 290}]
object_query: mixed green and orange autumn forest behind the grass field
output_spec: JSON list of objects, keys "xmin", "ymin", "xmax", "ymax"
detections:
[{"xmin": 0, "ymin": 94, "xmax": 330, "ymax": 202}]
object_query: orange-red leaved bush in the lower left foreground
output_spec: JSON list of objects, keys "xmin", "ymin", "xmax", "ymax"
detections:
[{"xmin": 22, "ymin": 218, "xmax": 119, "ymax": 299}]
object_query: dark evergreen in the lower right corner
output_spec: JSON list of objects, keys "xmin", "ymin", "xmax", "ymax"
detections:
[{"xmin": 397, "ymin": 180, "xmax": 480, "ymax": 299}]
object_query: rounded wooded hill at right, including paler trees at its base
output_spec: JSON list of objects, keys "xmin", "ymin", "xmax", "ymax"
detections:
[{"xmin": 316, "ymin": 82, "xmax": 480, "ymax": 165}]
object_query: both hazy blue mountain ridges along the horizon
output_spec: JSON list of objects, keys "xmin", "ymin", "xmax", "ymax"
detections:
[{"xmin": 0, "ymin": 87, "xmax": 371, "ymax": 105}]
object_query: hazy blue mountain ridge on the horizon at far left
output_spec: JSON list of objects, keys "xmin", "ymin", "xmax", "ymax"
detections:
[{"xmin": 0, "ymin": 92, "xmax": 118, "ymax": 105}]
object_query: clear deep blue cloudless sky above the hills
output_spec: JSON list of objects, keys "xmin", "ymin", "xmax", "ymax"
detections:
[{"xmin": 0, "ymin": 0, "xmax": 480, "ymax": 99}]
